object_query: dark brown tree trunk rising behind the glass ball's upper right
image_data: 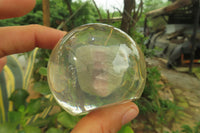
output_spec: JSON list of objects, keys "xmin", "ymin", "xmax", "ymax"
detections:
[{"xmin": 121, "ymin": 0, "xmax": 135, "ymax": 34}]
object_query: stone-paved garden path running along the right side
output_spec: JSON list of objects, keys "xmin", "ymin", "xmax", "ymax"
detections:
[{"xmin": 136, "ymin": 58, "xmax": 200, "ymax": 133}]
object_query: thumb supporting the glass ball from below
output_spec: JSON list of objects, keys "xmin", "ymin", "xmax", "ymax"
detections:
[{"xmin": 71, "ymin": 102, "xmax": 139, "ymax": 133}]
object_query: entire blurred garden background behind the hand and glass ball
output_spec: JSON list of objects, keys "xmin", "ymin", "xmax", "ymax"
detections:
[{"xmin": 0, "ymin": 0, "xmax": 200, "ymax": 133}]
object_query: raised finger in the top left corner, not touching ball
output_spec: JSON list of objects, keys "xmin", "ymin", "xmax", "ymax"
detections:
[{"xmin": 0, "ymin": 0, "xmax": 35, "ymax": 19}]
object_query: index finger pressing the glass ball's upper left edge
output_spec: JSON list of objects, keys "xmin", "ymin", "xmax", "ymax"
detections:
[{"xmin": 0, "ymin": 25, "xmax": 66, "ymax": 57}]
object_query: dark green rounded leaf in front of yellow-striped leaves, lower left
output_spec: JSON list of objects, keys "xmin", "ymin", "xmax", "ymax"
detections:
[{"xmin": 10, "ymin": 89, "xmax": 29, "ymax": 109}]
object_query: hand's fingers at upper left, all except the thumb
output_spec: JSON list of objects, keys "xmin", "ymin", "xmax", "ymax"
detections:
[{"xmin": 0, "ymin": 0, "xmax": 66, "ymax": 72}]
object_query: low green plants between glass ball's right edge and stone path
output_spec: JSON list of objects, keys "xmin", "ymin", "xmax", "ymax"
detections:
[{"xmin": 136, "ymin": 67, "xmax": 182, "ymax": 132}]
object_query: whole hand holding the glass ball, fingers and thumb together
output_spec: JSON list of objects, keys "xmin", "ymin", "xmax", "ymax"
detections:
[{"xmin": 0, "ymin": 0, "xmax": 139, "ymax": 133}]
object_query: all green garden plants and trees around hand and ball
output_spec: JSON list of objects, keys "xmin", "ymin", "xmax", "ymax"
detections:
[{"xmin": 0, "ymin": 0, "xmax": 200, "ymax": 133}]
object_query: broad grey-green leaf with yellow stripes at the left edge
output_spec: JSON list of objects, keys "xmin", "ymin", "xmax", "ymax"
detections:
[{"xmin": 0, "ymin": 56, "xmax": 23, "ymax": 123}]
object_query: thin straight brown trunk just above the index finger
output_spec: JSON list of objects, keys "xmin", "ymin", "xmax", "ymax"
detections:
[{"xmin": 42, "ymin": 0, "xmax": 50, "ymax": 27}]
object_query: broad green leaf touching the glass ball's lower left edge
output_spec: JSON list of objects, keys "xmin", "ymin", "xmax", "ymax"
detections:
[{"xmin": 34, "ymin": 81, "xmax": 51, "ymax": 95}]
